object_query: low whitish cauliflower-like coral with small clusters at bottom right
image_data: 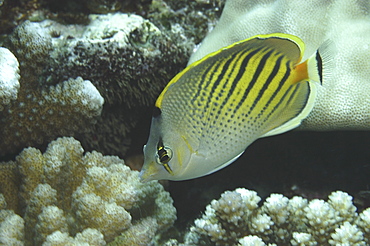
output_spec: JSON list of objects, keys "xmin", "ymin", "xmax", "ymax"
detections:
[{"xmin": 168, "ymin": 188, "xmax": 370, "ymax": 246}]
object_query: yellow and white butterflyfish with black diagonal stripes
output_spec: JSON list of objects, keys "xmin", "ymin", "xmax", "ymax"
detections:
[{"xmin": 140, "ymin": 33, "xmax": 322, "ymax": 181}]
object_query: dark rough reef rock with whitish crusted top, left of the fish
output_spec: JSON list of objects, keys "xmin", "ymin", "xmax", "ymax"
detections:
[{"xmin": 40, "ymin": 13, "xmax": 193, "ymax": 155}]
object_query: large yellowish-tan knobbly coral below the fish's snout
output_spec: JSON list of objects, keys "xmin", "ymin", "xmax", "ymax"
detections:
[{"xmin": 0, "ymin": 137, "xmax": 176, "ymax": 245}]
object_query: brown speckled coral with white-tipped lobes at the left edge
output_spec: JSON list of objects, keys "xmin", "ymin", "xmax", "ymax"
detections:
[{"xmin": 0, "ymin": 21, "xmax": 108, "ymax": 158}]
